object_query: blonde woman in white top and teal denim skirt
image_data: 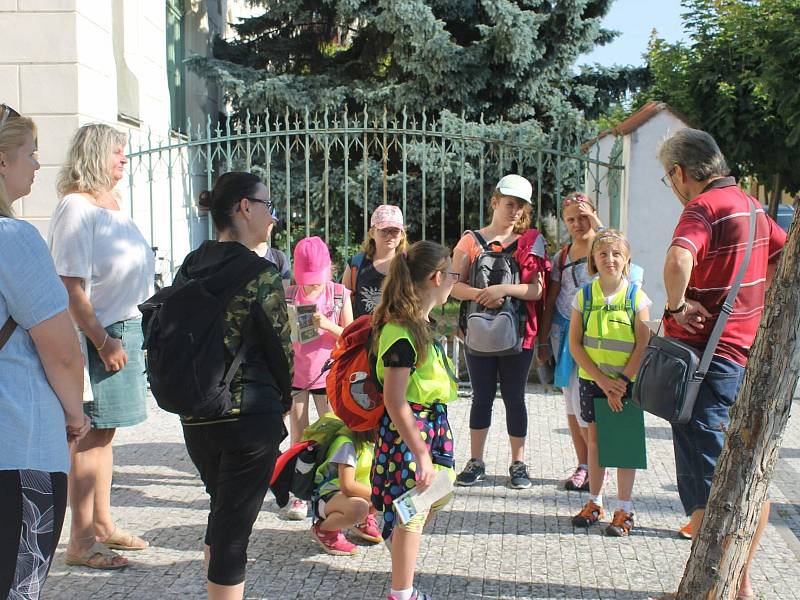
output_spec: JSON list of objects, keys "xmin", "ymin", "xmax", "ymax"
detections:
[{"xmin": 50, "ymin": 124, "xmax": 154, "ymax": 569}]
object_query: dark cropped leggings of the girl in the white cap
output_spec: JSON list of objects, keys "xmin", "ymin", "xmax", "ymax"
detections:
[{"xmin": 467, "ymin": 349, "xmax": 533, "ymax": 437}]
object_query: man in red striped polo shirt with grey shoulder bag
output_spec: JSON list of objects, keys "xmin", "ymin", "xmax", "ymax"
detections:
[{"xmin": 659, "ymin": 129, "xmax": 786, "ymax": 598}]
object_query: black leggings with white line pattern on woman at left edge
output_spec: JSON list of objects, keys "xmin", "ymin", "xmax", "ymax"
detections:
[{"xmin": 0, "ymin": 469, "xmax": 67, "ymax": 599}]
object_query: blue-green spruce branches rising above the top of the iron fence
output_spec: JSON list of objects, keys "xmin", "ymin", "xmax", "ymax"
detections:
[{"xmin": 195, "ymin": 0, "xmax": 614, "ymax": 131}]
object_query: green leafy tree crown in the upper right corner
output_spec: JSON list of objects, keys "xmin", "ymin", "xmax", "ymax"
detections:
[{"xmin": 637, "ymin": 0, "xmax": 800, "ymax": 196}]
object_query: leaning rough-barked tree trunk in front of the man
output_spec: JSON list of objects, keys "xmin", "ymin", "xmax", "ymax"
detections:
[{"xmin": 676, "ymin": 205, "xmax": 800, "ymax": 600}]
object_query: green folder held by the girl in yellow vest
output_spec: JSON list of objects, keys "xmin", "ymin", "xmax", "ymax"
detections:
[{"xmin": 594, "ymin": 398, "xmax": 647, "ymax": 469}]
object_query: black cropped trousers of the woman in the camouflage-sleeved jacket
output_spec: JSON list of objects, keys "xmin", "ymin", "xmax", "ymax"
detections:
[{"xmin": 183, "ymin": 415, "xmax": 283, "ymax": 585}]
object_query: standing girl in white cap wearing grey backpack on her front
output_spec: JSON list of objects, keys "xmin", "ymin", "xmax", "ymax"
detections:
[{"xmin": 451, "ymin": 175, "xmax": 549, "ymax": 489}]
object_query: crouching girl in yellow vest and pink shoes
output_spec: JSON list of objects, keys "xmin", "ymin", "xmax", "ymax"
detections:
[{"xmin": 311, "ymin": 425, "xmax": 382, "ymax": 555}]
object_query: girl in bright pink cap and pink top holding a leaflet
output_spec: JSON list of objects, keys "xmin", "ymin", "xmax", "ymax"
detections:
[{"xmin": 284, "ymin": 236, "xmax": 353, "ymax": 520}]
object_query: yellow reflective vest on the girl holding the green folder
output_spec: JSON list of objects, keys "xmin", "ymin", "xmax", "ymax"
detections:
[{"xmin": 578, "ymin": 279, "xmax": 642, "ymax": 381}]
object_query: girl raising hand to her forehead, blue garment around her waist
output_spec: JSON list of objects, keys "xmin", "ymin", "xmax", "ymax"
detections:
[{"xmin": 537, "ymin": 192, "xmax": 603, "ymax": 491}]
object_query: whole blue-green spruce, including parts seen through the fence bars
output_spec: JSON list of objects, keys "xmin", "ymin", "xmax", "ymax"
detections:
[{"xmin": 190, "ymin": 0, "xmax": 628, "ymax": 253}]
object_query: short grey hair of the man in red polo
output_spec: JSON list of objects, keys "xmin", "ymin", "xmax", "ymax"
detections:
[{"xmin": 658, "ymin": 127, "xmax": 731, "ymax": 181}]
